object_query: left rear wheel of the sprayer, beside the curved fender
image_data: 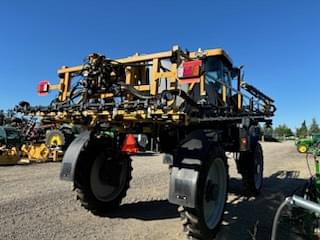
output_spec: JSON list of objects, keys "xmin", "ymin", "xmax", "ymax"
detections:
[{"xmin": 74, "ymin": 150, "xmax": 132, "ymax": 215}]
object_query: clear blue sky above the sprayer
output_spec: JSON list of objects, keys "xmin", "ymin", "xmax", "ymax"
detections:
[{"xmin": 0, "ymin": 0, "xmax": 320, "ymax": 129}]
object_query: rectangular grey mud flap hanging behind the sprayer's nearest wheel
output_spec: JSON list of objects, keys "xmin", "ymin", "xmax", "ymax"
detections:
[{"xmin": 169, "ymin": 167, "xmax": 199, "ymax": 208}]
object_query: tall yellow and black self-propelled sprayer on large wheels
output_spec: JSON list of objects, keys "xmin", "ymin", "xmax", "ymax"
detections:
[{"xmin": 20, "ymin": 47, "xmax": 276, "ymax": 239}]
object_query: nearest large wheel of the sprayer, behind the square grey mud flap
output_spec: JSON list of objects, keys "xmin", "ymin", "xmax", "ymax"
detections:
[{"xmin": 178, "ymin": 147, "xmax": 229, "ymax": 240}]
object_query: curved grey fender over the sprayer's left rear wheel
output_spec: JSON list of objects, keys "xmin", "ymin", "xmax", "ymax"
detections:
[{"xmin": 60, "ymin": 131, "xmax": 91, "ymax": 181}]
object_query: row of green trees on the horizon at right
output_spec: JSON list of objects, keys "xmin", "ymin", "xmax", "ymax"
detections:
[{"xmin": 270, "ymin": 118, "xmax": 320, "ymax": 138}]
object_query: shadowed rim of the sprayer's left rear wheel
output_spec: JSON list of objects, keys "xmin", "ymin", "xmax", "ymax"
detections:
[{"xmin": 90, "ymin": 154, "xmax": 128, "ymax": 202}]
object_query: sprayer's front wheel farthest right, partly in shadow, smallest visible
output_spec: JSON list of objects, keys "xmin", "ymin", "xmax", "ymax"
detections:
[{"xmin": 239, "ymin": 142, "xmax": 264, "ymax": 196}]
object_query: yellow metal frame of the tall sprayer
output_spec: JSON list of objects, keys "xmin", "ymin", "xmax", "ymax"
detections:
[{"xmin": 40, "ymin": 47, "xmax": 243, "ymax": 124}]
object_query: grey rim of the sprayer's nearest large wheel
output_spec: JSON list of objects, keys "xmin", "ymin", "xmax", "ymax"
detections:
[{"xmin": 203, "ymin": 158, "xmax": 227, "ymax": 229}]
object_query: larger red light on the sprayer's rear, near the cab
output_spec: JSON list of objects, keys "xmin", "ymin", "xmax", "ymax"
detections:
[{"xmin": 178, "ymin": 60, "xmax": 202, "ymax": 83}]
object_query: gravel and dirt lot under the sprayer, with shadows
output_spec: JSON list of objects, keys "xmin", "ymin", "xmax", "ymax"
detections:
[{"xmin": 0, "ymin": 142, "xmax": 308, "ymax": 240}]
